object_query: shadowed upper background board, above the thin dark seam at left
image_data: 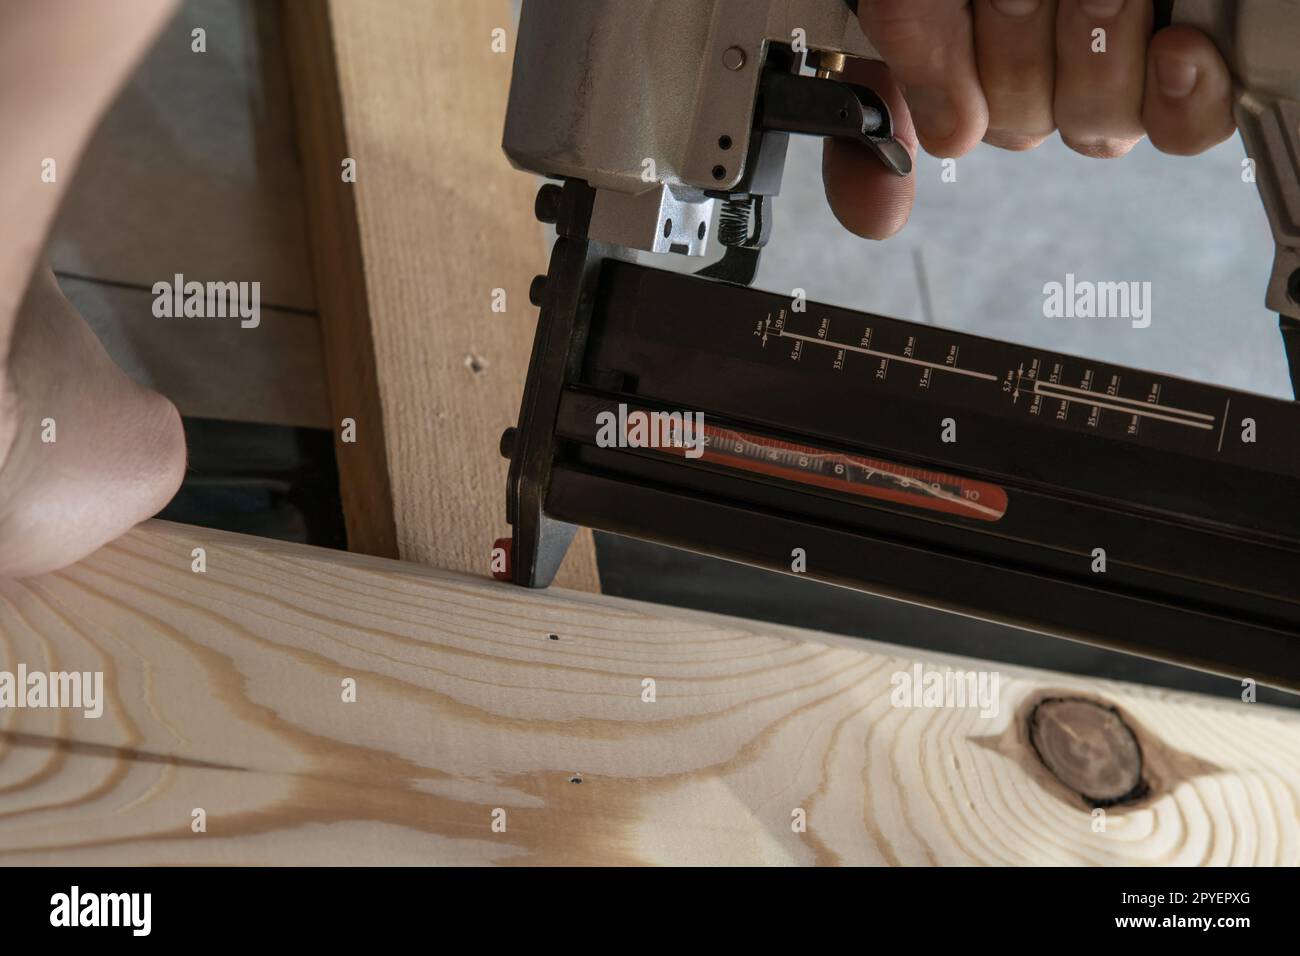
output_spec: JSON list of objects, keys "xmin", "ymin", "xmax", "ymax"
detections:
[{"xmin": 49, "ymin": 0, "xmax": 316, "ymax": 310}]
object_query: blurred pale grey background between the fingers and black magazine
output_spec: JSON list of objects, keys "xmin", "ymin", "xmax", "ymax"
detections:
[{"xmin": 758, "ymin": 137, "xmax": 1292, "ymax": 398}]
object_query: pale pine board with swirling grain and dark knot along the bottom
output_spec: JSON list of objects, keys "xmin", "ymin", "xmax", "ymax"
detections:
[{"xmin": 0, "ymin": 523, "xmax": 1300, "ymax": 865}]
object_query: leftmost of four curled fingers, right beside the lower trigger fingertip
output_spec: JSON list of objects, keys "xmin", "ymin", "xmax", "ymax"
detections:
[{"xmin": 859, "ymin": 0, "xmax": 988, "ymax": 156}]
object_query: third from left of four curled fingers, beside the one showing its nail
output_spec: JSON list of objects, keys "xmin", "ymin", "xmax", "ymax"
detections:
[{"xmin": 1054, "ymin": 0, "xmax": 1153, "ymax": 159}]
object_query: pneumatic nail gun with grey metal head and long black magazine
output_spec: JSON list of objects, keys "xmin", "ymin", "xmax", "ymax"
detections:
[{"xmin": 502, "ymin": 0, "xmax": 1300, "ymax": 689}]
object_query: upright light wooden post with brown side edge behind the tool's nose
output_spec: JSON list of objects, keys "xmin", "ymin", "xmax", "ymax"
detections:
[{"xmin": 285, "ymin": 0, "xmax": 597, "ymax": 589}]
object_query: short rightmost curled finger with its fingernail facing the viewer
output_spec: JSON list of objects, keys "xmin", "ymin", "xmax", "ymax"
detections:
[{"xmin": 1141, "ymin": 26, "xmax": 1236, "ymax": 156}]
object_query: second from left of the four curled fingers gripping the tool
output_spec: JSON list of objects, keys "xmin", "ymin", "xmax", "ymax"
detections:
[{"xmin": 974, "ymin": 0, "xmax": 1056, "ymax": 150}]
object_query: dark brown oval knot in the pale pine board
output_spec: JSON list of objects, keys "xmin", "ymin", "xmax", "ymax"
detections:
[{"xmin": 1028, "ymin": 697, "xmax": 1148, "ymax": 806}]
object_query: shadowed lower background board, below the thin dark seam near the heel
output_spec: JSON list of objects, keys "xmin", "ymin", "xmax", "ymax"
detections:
[{"xmin": 59, "ymin": 277, "xmax": 333, "ymax": 428}]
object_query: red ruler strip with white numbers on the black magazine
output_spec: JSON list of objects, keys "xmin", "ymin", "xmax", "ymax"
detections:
[{"xmin": 659, "ymin": 419, "xmax": 1006, "ymax": 522}]
